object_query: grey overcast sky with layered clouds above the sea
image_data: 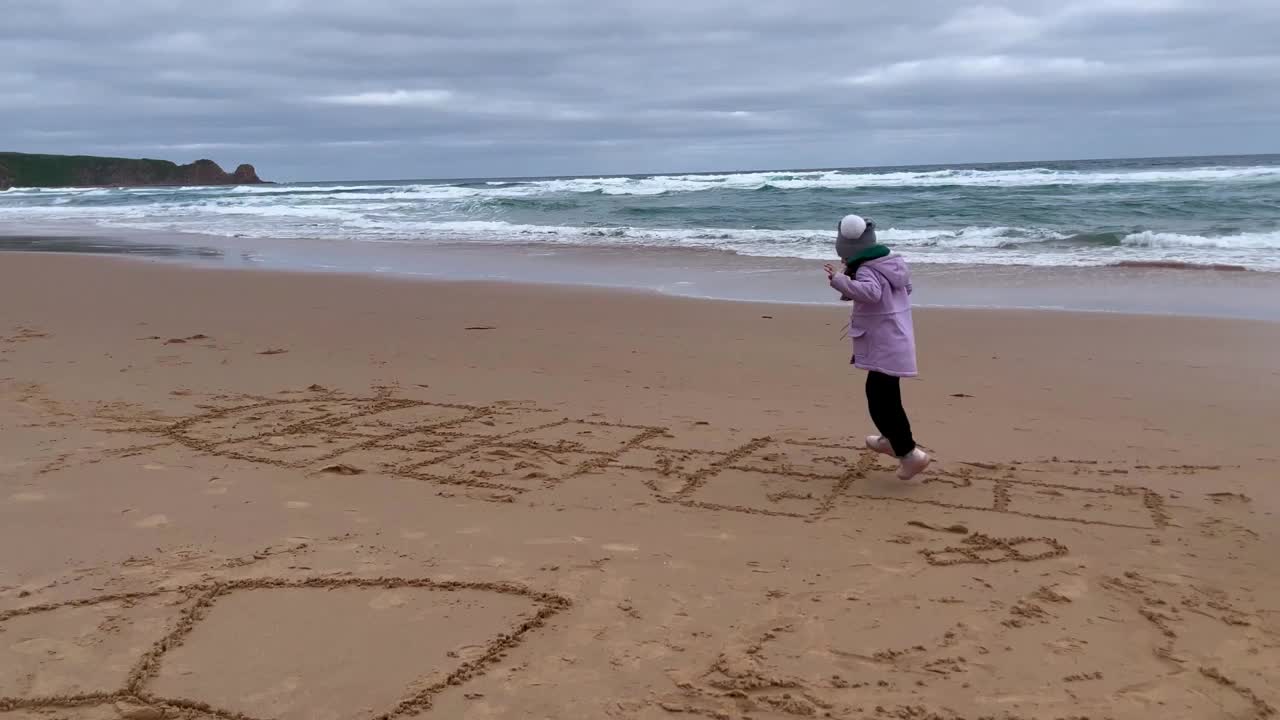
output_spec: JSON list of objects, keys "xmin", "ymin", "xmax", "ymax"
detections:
[{"xmin": 0, "ymin": 0, "xmax": 1280, "ymax": 181}]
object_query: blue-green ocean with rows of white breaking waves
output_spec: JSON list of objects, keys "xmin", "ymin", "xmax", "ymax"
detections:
[{"xmin": 0, "ymin": 155, "xmax": 1280, "ymax": 273}]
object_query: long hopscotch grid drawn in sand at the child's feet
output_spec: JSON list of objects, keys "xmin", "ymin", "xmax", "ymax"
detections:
[{"xmin": 99, "ymin": 391, "xmax": 1170, "ymax": 529}]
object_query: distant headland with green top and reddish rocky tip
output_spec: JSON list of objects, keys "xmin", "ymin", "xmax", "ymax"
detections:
[{"xmin": 0, "ymin": 152, "xmax": 262, "ymax": 190}]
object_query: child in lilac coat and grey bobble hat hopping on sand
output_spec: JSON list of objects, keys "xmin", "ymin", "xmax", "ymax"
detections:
[{"xmin": 827, "ymin": 215, "xmax": 929, "ymax": 480}]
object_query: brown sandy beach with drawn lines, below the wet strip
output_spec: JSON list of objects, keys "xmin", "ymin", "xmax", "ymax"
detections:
[{"xmin": 0, "ymin": 255, "xmax": 1280, "ymax": 720}]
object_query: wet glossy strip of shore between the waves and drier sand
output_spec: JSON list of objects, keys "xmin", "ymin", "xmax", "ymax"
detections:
[{"xmin": 0, "ymin": 225, "xmax": 1280, "ymax": 322}]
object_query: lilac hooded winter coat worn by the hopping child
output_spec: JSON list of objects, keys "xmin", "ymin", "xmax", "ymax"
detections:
[{"xmin": 831, "ymin": 255, "xmax": 918, "ymax": 378}]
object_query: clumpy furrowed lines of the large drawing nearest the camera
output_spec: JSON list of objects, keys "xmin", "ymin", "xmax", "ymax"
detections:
[{"xmin": 0, "ymin": 578, "xmax": 572, "ymax": 720}]
